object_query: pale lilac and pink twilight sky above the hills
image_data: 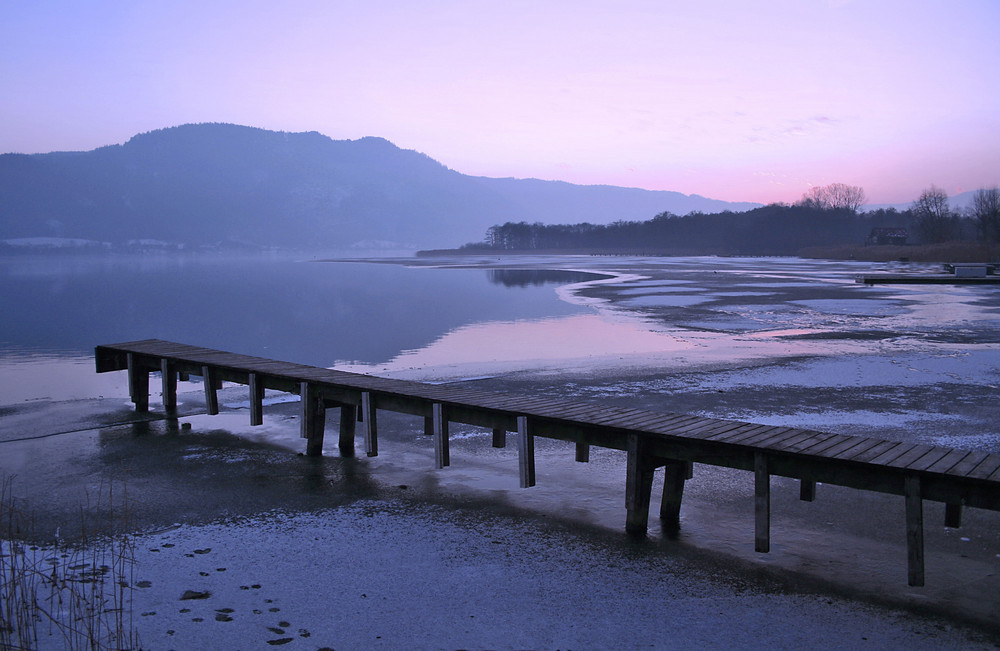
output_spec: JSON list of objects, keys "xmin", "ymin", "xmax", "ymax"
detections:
[{"xmin": 0, "ymin": 0, "xmax": 1000, "ymax": 203}]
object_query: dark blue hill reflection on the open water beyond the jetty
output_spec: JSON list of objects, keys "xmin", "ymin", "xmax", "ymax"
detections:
[{"xmin": 0, "ymin": 256, "xmax": 585, "ymax": 366}]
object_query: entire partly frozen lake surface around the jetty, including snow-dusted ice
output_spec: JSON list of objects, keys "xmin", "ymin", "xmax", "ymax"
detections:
[{"xmin": 0, "ymin": 257, "xmax": 1000, "ymax": 648}]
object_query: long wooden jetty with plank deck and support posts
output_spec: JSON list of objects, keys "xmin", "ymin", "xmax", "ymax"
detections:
[{"xmin": 95, "ymin": 339, "xmax": 1000, "ymax": 586}]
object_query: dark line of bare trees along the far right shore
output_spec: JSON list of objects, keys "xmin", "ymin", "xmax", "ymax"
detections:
[{"xmin": 426, "ymin": 183, "xmax": 1000, "ymax": 262}]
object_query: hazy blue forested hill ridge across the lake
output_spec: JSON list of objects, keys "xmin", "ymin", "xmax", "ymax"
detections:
[{"xmin": 0, "ymin": 124, "xmax": 758, "ymax": 249}]
